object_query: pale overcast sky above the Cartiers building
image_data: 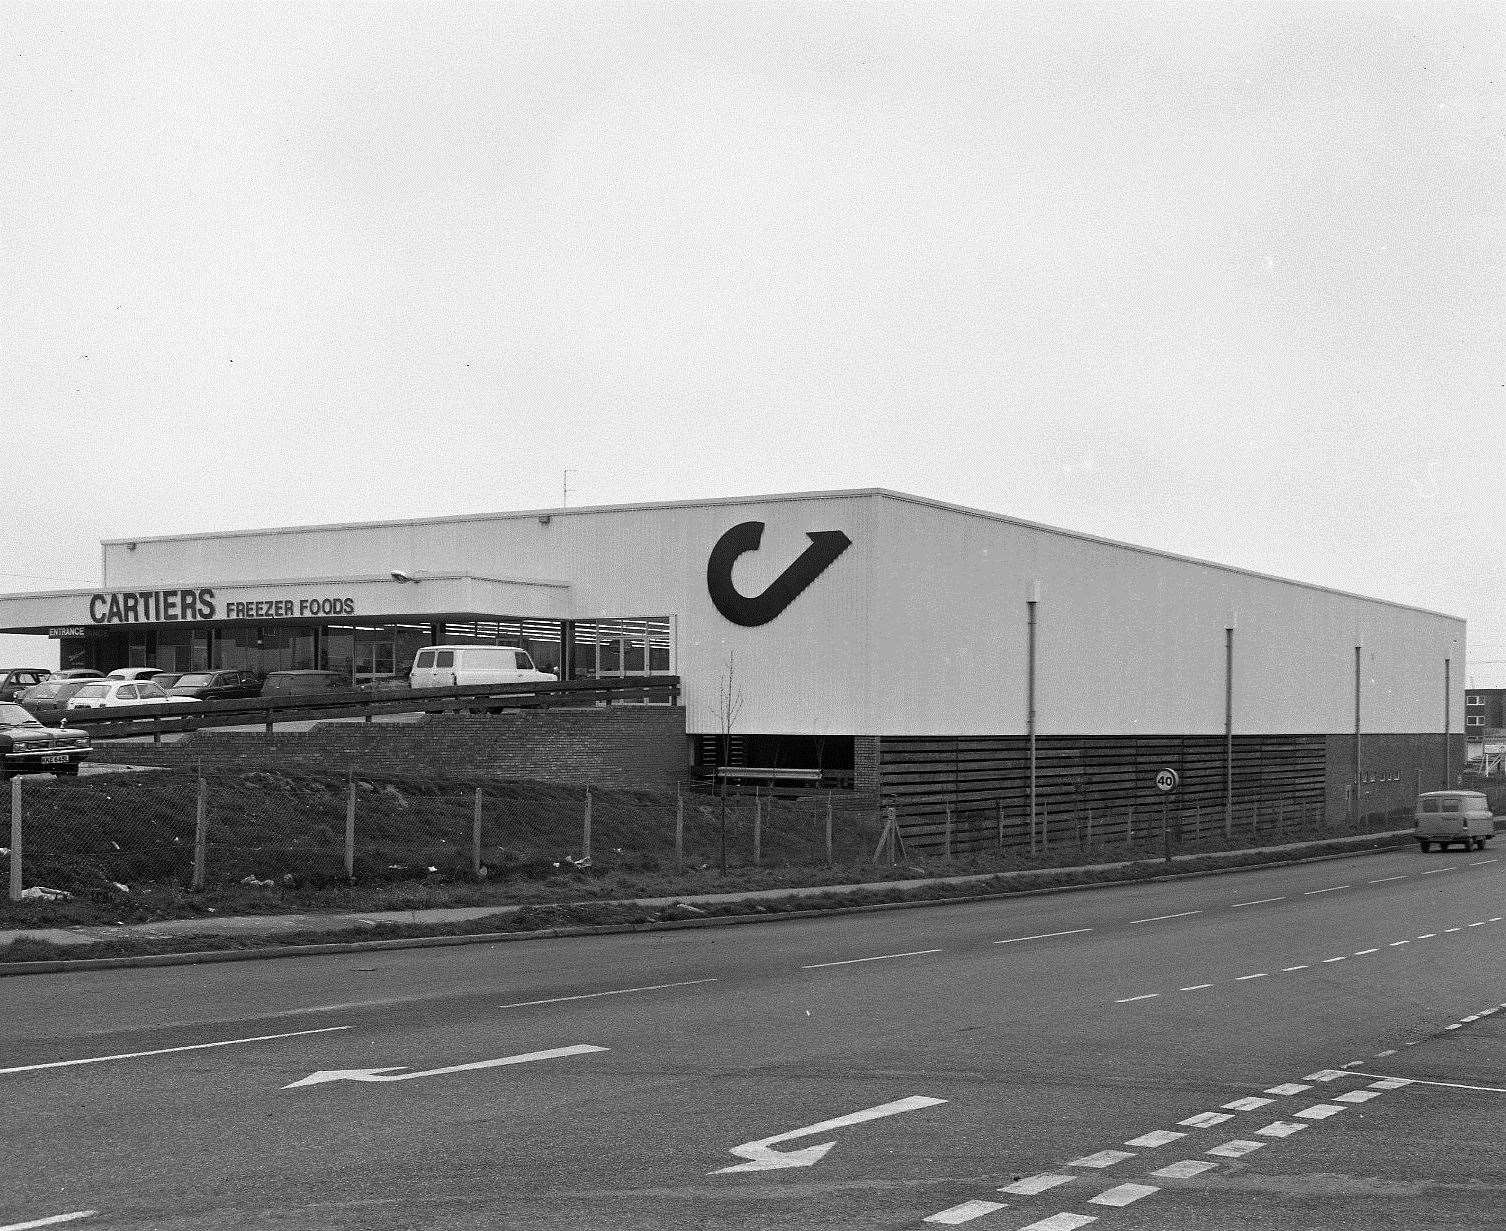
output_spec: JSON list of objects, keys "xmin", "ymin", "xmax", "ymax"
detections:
[{"xmin": 0, "ymin": 3, "xmax": 1506, "ymax": 672}]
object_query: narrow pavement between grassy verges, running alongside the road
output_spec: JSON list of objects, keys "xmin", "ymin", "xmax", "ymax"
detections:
[{"xmin": 0, "ymin": 825, "xmax": 1411, "ymax": 952}]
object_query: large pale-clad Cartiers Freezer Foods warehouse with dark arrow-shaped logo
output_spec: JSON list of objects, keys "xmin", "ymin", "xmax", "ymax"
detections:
[{"xmin": 0, "ymin": 490, "xmax": 1465, "ymax": 837}]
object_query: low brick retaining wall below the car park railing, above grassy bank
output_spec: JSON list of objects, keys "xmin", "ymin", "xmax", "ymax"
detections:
[{"xmin": 93, "ymin": 705, "xmax": 688, "ymax": 790}]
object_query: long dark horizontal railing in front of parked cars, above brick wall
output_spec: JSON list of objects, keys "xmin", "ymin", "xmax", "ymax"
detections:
[{"xmin": 63, "ymin": 675, "xmax": 679, "ymax": 741}]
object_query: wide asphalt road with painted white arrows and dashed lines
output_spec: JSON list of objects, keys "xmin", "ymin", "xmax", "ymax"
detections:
[{"xmin": 0, "ymin": 850, "xmax": 1506, "ymax": 1231}]
